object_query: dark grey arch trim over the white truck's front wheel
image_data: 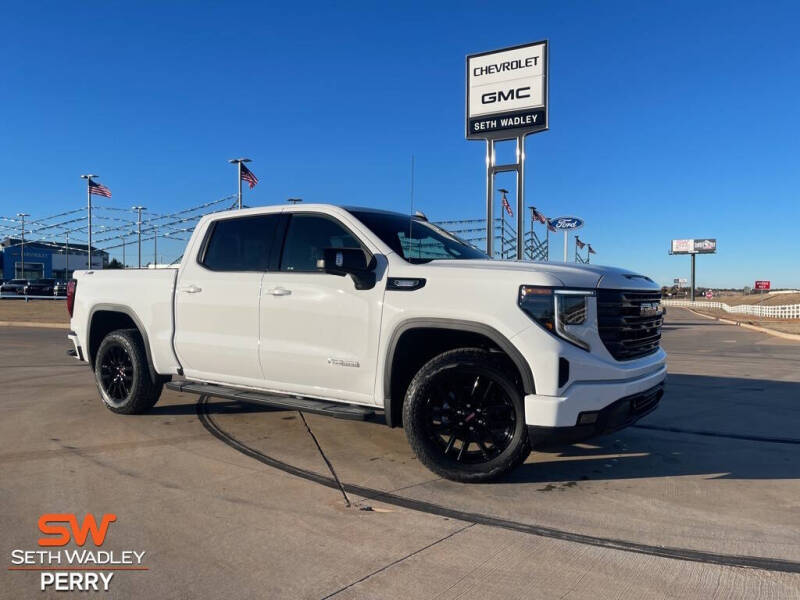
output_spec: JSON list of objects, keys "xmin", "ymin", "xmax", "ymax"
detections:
[{"xmin": 382, "ymin": 318, "xmax": 536, "ymax": 427}]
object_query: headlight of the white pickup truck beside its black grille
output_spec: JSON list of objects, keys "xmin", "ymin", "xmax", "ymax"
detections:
[{"xmin": 519, "ymin": 285, "xmax": 594, "ymax": 350}]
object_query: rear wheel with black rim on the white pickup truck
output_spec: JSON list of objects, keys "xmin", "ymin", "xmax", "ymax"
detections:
[{"xmin": 94, "ymin": 329, "xmax": 164, "ymax": 415}]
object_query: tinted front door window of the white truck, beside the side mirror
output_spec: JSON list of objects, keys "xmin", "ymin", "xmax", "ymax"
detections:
[{"xmin": 281, "ymin": 213, "xmax": 363, "ymax": 273}]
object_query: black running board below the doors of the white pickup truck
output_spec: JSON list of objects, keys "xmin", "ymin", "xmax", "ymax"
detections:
[{"xmin": 166, "ymin": 381, "xmax": 375, "ymax": 421}]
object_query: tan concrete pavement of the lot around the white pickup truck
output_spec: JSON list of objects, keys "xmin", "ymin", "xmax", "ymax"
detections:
[{"xmin": 0, "ymin": 309, "xmax": 800, "ymax": 599}]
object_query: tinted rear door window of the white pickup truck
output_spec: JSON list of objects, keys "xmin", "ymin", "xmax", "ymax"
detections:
[{"xmin": 200, "ymin": 213, "xmax": 280, "ymax": 271}]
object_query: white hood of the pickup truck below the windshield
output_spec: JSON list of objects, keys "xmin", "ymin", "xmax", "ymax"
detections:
[{"xmin": 418, "ymin": 260, "xmax": 661, "ymax": 290}]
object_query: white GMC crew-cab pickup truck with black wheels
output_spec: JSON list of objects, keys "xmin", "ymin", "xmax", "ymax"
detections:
[{"xmin": 67, "ymin": 205, "xmax": 666, "ymax": 481}]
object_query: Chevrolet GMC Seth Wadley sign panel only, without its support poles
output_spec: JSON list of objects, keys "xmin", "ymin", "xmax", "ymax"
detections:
[{"xmin": 467, "ymin": 40, "xmax": 548, "ymax": 140}]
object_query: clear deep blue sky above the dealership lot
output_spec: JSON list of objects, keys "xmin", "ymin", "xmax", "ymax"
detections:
[{"xmin": 0, "ymin": 1, "xmax": 800, "ymax": 287}]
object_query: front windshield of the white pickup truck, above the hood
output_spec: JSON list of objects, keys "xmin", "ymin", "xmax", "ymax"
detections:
[{"xmin": 348, "ymin": 209, "xmax": 489, "ymax": 263}]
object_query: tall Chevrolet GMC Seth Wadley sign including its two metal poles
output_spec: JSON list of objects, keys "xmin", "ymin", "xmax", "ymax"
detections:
[{"xmin": 466, "ymin": 40, "xmax": 549, "ymax": 260}]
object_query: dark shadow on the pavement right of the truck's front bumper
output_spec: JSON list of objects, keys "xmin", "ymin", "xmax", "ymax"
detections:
[{"xmin": 504, "ymin": 375, "xmax": 800, "ymax": 482}]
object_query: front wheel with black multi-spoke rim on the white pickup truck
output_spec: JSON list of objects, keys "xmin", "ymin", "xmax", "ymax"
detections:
[{"xmin": 403, "ymin": 348, "xmax": 531, "ymax": 482}]
